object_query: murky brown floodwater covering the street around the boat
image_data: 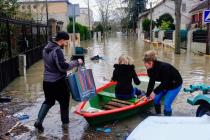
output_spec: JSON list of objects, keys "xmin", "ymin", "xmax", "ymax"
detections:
[{"xmin": 3, "ymin": 33, "xmax": 210, "ymax": 140}]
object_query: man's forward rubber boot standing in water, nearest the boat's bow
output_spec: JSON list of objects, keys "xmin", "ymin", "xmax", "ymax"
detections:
[{"xmin": 61, "ymin": 109, "xmax": 69, "ymax": 130}]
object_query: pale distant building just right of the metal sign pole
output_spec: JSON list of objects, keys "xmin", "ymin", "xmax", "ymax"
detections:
[{"xmin": 76, "ymin": 8, "xmax": 94, "ymax": 30}]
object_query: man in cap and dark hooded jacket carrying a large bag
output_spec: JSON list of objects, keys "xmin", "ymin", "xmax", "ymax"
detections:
[{"xmin": 34, "ymin": 32, "xmax": 83, "ymax": 132}]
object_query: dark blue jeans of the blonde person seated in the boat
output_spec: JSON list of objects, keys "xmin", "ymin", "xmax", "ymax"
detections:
[{"xmin": 115, "ymin": 88, "xmax": 141, "ymax": 100}]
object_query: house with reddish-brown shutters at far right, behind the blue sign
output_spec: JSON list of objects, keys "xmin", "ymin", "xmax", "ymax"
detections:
[{"xmin": 190, "ymin": 0, "xmax": 208, "ymax": 28}]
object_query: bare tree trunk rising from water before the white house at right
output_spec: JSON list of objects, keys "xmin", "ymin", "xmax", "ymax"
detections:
[{"xmin": 174, "ymin": 0, "xmax": 182, "ymax": 54}]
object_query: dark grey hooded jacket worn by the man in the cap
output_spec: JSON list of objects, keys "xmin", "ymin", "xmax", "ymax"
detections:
[{"xmin": 43, "ymin": 42, "xmax": 78, "ymax": 82}]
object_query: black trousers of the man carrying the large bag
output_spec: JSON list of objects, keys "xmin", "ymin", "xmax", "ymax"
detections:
[{"xmin": 43, "ymin": 78, "xmax": 70, "ymax": 123}]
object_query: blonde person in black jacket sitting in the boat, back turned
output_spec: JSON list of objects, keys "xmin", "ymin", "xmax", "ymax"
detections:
[{"xmin": 112, "ymin": 54, "xmax": 141, "ymax": 100}]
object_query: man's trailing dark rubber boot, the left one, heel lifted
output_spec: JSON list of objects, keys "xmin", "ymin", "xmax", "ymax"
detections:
[{"xmin": 34, "ymin": 104, "xmax": 51, "ymax": 133}]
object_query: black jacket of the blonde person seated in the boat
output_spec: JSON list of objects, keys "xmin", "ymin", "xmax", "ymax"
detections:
[{"xmin": 112, "ymin": 64, "xmax": 140, "ymax": 95}]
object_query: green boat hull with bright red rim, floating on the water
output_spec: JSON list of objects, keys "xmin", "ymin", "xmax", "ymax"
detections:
[{"xmin": 75, "ymin": 75, "xmax": 153, "ymax": 126}]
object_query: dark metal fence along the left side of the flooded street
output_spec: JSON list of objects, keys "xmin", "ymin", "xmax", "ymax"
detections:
[{"xmin": 0, "ymin": 15, "xmax": 50, "ymax": 91}]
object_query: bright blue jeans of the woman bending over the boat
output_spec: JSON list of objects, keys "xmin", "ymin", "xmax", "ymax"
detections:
[{"xmin": 154, "ymin": 84, "xmax": 182, "ymax": 112}]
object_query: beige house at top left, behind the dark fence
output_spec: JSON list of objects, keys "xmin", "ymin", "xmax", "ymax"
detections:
[{"xmin": 19, "ymin": 0, "xmax": 71, "ymax": 31}]
